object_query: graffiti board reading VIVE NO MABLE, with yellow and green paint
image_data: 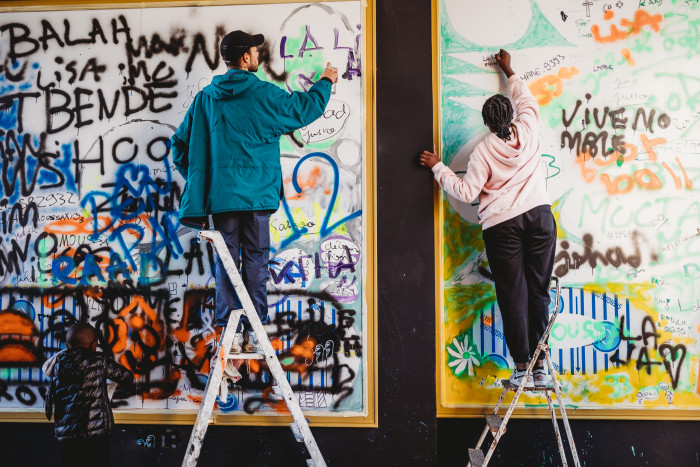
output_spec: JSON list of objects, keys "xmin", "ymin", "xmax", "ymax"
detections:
[{"xmin": 438, "ymin": 0, "xmax": 700, "ymax": 410}]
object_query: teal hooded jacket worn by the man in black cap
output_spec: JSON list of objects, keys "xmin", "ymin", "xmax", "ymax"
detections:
[{"xmin": 171, "ymin": 70, "xmax": 331, "ymax": 228}]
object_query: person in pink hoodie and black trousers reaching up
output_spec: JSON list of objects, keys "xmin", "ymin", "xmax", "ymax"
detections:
[{"xmin": 420, "ymin": 49, "xmax": 556, "ymax": 387}]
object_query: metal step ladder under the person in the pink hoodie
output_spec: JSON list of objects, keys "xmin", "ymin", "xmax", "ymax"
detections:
[{"xmin": 467, "ymin": 277, "xmax": 581, "ymax": 467}]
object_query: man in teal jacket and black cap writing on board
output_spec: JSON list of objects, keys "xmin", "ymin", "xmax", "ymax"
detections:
[{"xmin": 171, "ymin": 31, "xmax": 338, "ymax": 352}]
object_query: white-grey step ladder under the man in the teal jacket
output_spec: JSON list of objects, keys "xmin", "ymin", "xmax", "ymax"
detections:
[{"xmin": 182, "ymin": 230, "xmax": 326, "ymax": 467}]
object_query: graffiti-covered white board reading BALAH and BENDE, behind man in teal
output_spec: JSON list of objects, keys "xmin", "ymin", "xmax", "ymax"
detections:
[{"xmin": 0, "ymin": 2, "xmax": 368, "ymax": 420}]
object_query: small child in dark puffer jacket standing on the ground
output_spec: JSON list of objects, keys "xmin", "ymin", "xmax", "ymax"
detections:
[{"xmin": 44, "ymin": 323, "xmax": 134, "ymax": 467}]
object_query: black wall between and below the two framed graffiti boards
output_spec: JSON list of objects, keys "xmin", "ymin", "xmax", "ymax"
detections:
[{"xmin": 0, "ymin": 0, "xmax": 700, "ymax": 467}]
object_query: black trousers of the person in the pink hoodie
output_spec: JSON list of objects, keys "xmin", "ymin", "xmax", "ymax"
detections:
[{"xmin": 483, "ymin": 205, "xmax": 557, "ymax": 363}]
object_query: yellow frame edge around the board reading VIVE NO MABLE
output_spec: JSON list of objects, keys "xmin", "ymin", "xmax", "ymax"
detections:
[{"xmin": 431, "ymin": 0, "xmax": 700, "ymax": 421}]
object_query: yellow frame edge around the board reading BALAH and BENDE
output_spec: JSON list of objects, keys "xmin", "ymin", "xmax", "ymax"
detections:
[{"xmin": 0, "ymin": 0, "xmax": 379, "ymax": 428}]
